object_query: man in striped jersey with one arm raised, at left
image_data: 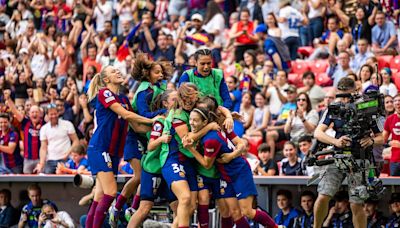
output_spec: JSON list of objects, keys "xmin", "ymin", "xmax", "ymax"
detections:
[{"xmin": 6, "ymin": 99, "xmax": 43, "ymax": 174}]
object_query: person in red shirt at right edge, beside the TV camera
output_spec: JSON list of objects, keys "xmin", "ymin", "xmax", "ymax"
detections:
[{"xmin": 383, "ymin": 94, "xmax": 400, "ymax": 176}]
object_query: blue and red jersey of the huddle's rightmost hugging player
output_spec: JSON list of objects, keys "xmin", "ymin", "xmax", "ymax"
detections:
[{"xmin": 201, "ymin": 131, "xmax": 248, "ymax": 182}]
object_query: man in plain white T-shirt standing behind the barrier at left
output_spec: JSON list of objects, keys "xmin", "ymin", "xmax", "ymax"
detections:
[{"xmin": 34, "ymin": 104, "xmax": 79, "ymax": 173}]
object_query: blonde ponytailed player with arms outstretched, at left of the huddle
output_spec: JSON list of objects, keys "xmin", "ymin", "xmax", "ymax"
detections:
[{"xmin": 86, "ymin": 66, "xmax": 153, "ymax": 228}]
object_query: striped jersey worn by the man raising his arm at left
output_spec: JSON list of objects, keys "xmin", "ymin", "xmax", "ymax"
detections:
[{"xmin": 21, "ymin": 117, "xmax": 43, "ymax": 160}]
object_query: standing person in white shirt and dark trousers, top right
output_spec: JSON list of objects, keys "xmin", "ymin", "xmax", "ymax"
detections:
[{"xmin": 277, "ymin": 0, "xmax": 308, "ymax": 60}]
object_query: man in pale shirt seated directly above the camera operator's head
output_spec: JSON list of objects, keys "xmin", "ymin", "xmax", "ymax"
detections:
[{"xmin": 327, "ymin": 51, "xmax": 351, "ymax": 87}]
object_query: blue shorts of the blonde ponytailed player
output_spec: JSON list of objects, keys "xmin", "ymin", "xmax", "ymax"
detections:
[{"xmin": 87, "ymin": 146, "xmax": 119, "ymax": 175}]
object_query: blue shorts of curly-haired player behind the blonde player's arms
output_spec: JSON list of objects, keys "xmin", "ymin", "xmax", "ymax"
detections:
[{"xmin": 124, "ymin": 130, "xmax": 147, "ymax": 162}]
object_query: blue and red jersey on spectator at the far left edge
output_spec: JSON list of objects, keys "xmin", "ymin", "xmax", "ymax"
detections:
[{"xmin": 0, "ymin": 129, "xmax": 23, "ymax": 169}]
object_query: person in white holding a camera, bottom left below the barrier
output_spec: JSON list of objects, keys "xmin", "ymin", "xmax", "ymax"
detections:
[{"xmin": 38, "ymin": 204, "xmax": 75, "ymax": 228}]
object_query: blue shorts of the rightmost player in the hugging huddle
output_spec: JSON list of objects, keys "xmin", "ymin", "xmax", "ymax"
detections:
[{"xmin": 230, "ymin": 165, "xmax": 257, "ymax": 200}]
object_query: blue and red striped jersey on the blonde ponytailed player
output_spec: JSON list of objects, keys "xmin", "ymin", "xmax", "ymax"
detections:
[{"xmin": 89, "ymin": 88, "xmax": 133, "ymax": 157}]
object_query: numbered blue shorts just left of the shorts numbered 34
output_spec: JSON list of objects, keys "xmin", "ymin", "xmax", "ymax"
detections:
[{"xmin": 140, "ymin": 169, "xmax": 176, "ymax": 202}]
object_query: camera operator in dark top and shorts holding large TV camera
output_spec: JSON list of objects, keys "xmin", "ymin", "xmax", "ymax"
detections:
[{"xmin": 314, "ymin": 77, "xmax": 383, "ymax": 228}]
